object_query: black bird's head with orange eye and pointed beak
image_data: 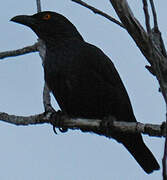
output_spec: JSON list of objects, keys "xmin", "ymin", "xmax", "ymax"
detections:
[{"xmin": 11, "ymin": 11, "xmax": 82, "ymax": 40}]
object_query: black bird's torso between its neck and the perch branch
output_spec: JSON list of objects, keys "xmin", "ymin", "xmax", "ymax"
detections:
[{"xmin": 44, "ymin": 41, "xmax": 134, "ymax": 121}]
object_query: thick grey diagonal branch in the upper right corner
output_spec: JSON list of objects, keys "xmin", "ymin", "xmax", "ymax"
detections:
[{"xmin": 110, "ymin": 0, "xmax": 167, "ymax": 91}]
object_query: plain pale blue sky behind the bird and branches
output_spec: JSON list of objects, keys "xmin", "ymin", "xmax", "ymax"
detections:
[{"xmin": 0, "ymin": 0, "xmax": 167, "ymax": 180}]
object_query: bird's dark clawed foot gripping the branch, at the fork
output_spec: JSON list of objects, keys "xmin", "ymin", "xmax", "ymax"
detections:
[{"xmin": 50, "ymin": 110, "xmax": 68, "ymax": 134}]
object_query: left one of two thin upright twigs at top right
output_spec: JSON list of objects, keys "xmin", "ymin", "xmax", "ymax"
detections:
[{"xmin": 143, "ymin": 0, "xmax": 151, "ymax": 34}]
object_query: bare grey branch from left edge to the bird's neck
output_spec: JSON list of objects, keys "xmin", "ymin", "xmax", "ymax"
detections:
[{"xmin": 0, "ymin": 43, "xmax": 38, "ymax": 59}]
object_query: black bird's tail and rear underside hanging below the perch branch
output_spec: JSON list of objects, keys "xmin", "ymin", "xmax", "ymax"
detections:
[{"xmin": 87, "ymin": 125, "xmax": 160, "ymax": 174}]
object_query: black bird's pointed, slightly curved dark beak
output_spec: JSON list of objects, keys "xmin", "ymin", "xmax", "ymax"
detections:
[{"xmin": 11, "ymin": 15, "xmax": 36, "ymax": 27}]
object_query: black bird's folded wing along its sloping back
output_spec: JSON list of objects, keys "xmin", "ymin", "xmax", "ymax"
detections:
[{"xmin": 72, "ymin": 43, "xmax": 136, "ymax": 121}]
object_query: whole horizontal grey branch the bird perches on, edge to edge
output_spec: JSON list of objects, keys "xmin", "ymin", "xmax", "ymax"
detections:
[{"xmin": 0, "ymin": 112, "xmax": 165, "ymax": 137}]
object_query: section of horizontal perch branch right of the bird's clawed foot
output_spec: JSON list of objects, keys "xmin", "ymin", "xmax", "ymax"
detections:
[{"xmin": 61, "ymin": 117, "xmax": 165, "ymax": 137}]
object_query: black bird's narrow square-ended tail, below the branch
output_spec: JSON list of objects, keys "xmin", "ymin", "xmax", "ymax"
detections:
[{"xmin": 121, "ymin": 134, "xmax": 160, "ymax": 174}]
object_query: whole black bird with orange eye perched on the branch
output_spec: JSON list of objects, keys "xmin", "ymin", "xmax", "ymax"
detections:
[{"xmin": 11, "ymin": 11, "xmax": 159, "ymax": 173}]
